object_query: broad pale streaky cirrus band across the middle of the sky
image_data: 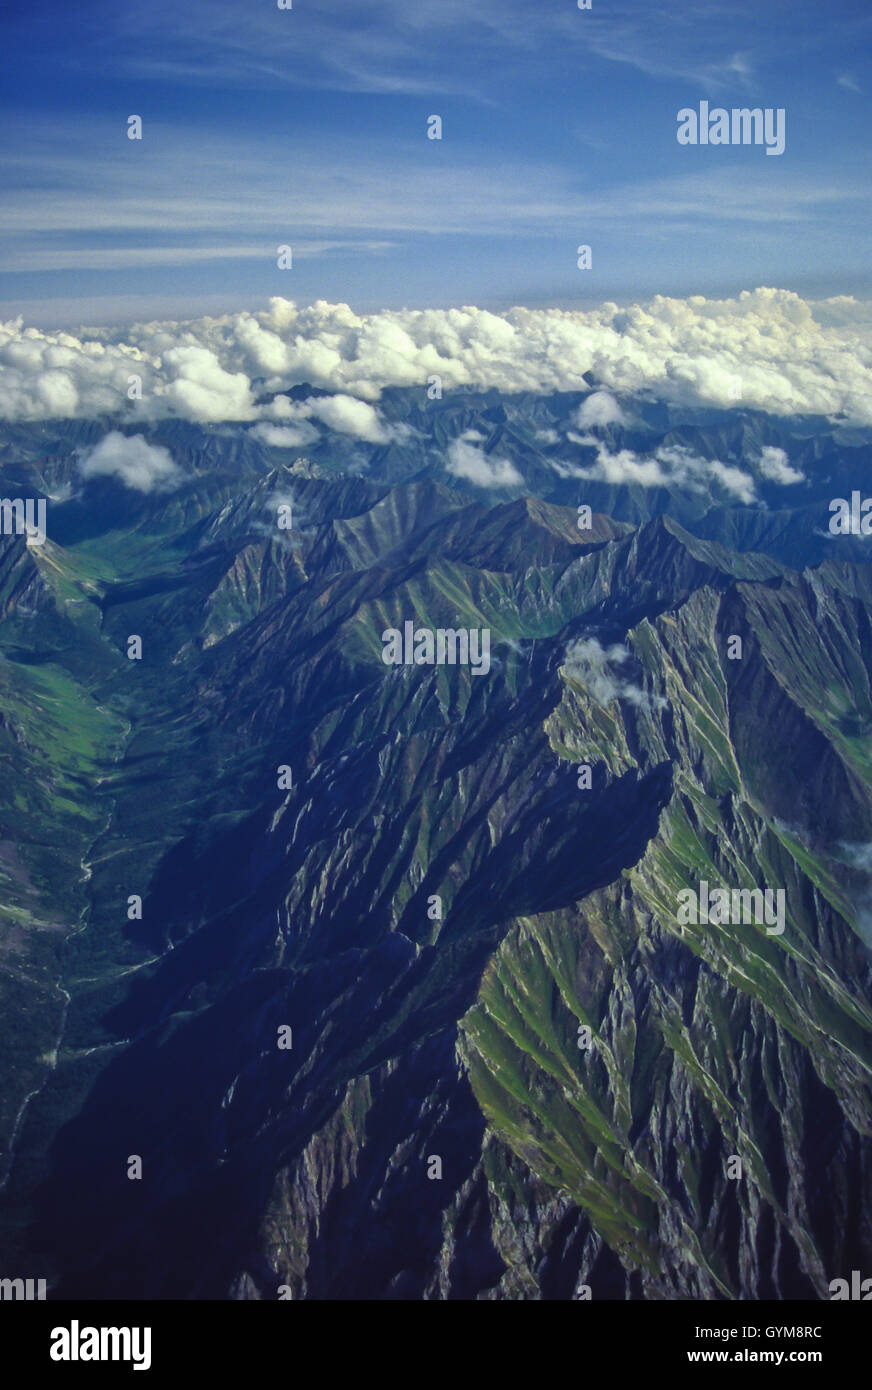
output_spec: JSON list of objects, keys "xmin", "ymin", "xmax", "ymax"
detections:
[{"xmin": 0, "ymin": 120, "xmax": 872, "ymax": 262}]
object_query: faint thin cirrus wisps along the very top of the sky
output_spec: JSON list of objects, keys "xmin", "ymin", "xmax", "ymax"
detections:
[{"xmin": 0, "ymin": 0, "xmax": 868, "ymax": 99}]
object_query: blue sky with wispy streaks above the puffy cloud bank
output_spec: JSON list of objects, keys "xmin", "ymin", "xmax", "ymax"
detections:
[{"xmin": 0, "ymin": 0, "xmax": 872, "ymax": 327}]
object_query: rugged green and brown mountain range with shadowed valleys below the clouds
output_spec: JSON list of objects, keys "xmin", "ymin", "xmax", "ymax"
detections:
[{"xmin": 0, "ymin": 392, "xmax": 872, "ymax": 1300}]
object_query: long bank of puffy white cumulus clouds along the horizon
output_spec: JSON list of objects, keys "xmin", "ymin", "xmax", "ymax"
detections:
[{"xmin": 0, "ymin": 289, "xmax": 872, "ymax": 422}]
